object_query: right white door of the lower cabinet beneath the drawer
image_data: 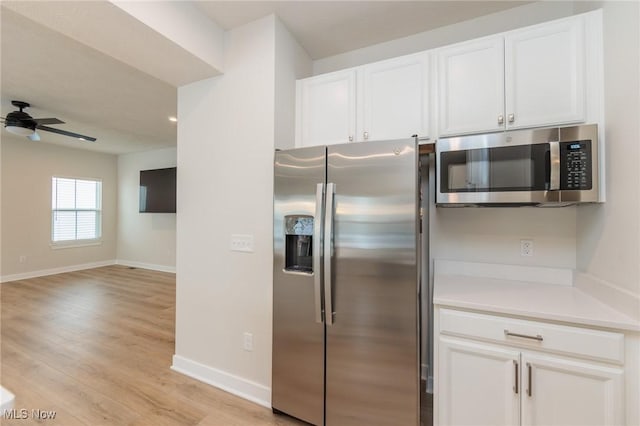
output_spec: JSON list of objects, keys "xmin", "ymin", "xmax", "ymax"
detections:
[{"xmin": 522, "ymin": 352, "xmax": 624, "ymax": 426}]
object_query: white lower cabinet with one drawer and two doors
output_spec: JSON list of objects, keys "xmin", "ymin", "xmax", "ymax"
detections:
[{"xmin": 434, "ymin": 309, "xmax": 624, "ymax": 426}]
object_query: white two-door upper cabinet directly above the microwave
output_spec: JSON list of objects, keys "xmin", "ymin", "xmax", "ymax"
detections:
[{"xmin": 438, "ymin": 15, "xmax": 586, "ymax": 135}]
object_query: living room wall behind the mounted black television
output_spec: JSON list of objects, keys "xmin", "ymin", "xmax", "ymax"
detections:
[{"xmin": 117, "ymin": 148, "xmax": 177, "ymax": 272}]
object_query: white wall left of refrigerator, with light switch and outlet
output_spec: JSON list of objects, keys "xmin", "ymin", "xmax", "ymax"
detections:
[{"xmin": 173, "ymin": 16, "xmax": 275, "ymax": 405}]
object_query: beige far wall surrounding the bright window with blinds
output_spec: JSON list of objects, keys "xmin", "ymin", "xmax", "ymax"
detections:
[{"xmin": 0, "ymin": 135, "xmax": 118, "ymax": 281}]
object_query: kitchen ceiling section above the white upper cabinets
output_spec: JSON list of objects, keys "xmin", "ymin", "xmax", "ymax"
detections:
[{"xmin": 198, "ymin": 0, "xmax": 531, "ymax": 60}]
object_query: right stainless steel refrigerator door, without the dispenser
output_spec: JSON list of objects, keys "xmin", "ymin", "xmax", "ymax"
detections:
[{"xmin": 325, "ymin": 139, "xmax": 420, "ymax": 426}]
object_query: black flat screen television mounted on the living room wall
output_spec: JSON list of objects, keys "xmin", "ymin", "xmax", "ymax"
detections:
[{"xmin": 140, "ymin": 167, "xmax": 176, "ymax": 213}]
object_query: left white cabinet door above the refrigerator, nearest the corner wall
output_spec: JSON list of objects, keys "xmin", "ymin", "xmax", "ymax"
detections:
[{"xmin": 296, "ymin": 69, "xmax": 356, "ymax": 147}]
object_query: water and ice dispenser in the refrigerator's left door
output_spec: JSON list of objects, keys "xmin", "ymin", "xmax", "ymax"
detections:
[{"xmin": 284, "ymin": 215, "xmax": 313, "ymax": 274}]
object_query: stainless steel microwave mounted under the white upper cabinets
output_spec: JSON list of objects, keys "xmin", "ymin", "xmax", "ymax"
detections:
[{"xmin": 436, "ymin": 124, "xmax": 604, "ymax": 207}]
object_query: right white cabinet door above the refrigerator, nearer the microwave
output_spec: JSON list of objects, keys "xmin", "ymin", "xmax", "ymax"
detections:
[{"xmin": 356, "ymin": 52, "xmax": 430, "ymax": 140}]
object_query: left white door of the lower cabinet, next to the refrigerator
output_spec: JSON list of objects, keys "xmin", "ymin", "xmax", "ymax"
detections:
[{"xmin": 436, "ymin": 337, "xmax": 520, "ymax": 426}]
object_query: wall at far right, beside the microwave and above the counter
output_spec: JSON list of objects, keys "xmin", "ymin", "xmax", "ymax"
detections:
[{"xmin": 577, "ymin": 1, "xmax": 640, "ymax": 299}]
